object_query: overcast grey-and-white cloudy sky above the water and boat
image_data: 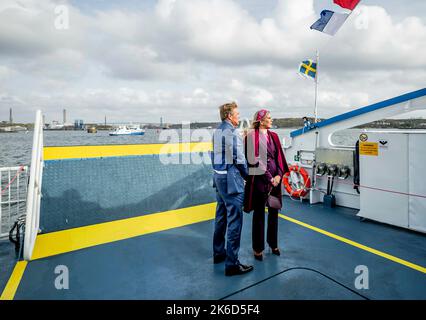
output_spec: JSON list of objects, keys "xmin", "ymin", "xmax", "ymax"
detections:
[{"xmin": 0, "ymin": 0, "xmax": 426, "ymax": 123}]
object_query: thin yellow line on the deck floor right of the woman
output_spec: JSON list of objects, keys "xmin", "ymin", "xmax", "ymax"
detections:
[{"xmin": 279, "ymin": 214, "xmax": 426, "ymax": 273}]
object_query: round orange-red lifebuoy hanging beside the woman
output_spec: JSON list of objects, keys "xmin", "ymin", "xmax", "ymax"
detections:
[{"xmin": 283, "ymin": 165, "xmax": 311, "ymax": 198}]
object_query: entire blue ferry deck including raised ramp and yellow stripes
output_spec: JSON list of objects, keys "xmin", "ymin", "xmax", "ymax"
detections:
[{"xmin": 0, "ymin": 143, "xmax": 426, "ymax": 300}]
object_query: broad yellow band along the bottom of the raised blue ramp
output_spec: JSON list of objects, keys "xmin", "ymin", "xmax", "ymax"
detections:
[{"xmin": 31, "ymin": 202, "xmax": 216, "ymax": 260}]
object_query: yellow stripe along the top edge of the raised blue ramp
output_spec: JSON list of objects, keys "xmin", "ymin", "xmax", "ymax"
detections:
[{"xmin": 43, "ymin": 142, "xmax": 212, "ymax": 160}]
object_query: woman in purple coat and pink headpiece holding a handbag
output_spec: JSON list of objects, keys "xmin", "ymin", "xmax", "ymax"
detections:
[{"xmin": 244, "ymin": 109, "xmax": 289, "ymax": 261}]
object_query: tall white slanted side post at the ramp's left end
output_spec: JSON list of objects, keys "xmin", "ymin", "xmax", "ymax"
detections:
[{"xmin": 24, "ymin": 110, "xmax": 44, "ymax": 260}]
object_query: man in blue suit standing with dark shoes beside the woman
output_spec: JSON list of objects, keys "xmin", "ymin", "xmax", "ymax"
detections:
[{"xmin": 212, "ymin": 102, "xmax": 253, "ymax": 276}]
